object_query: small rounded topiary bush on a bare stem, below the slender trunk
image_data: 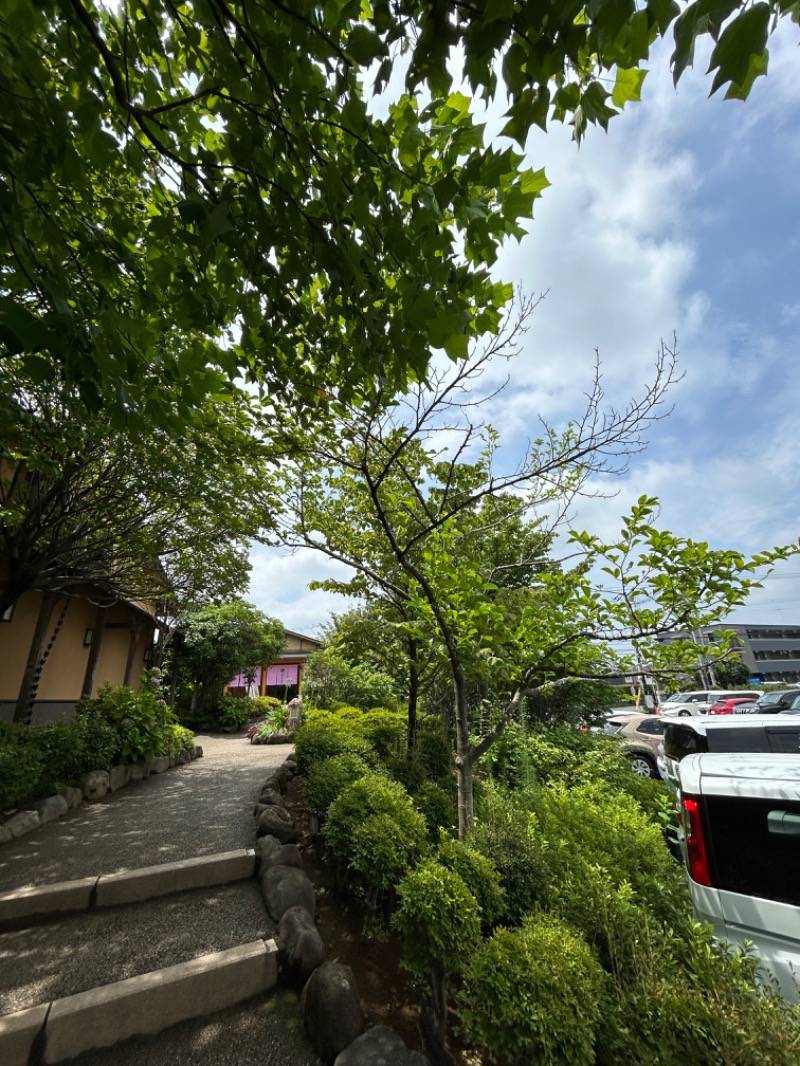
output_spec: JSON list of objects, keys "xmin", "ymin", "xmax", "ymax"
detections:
[{"xmin": 391, "ymin": 859, "xmax": 480, "ymax": 979}]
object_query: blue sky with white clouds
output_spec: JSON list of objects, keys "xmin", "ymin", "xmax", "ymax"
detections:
[{"xmin": 250, "ymin": 20, "xmax": 800, "ymax": 633}]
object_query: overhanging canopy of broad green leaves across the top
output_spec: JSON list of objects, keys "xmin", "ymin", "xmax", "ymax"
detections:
[{"xmin": 0, "ymin": 0, "xmax": 800, "ymax": 425}]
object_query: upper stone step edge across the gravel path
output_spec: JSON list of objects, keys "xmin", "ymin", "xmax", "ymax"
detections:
[{"xmin": 0, "ymin": 847, "xmax": 256, "ymax": 933}]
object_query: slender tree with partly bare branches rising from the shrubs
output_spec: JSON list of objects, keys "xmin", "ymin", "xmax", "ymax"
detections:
[{"xmin": 284, "ymin": 323, "xmax": 789, "ymax": 836}]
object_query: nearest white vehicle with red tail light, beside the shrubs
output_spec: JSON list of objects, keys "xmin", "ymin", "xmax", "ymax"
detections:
[{"xmin": 679, "ymin": 750, "xmax": 800, "ymax": 1001}]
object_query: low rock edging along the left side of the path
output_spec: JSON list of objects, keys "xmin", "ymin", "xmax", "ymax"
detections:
[{"xmin": 0, "ymin": 744, "xmax": 203, "ymax": 844}]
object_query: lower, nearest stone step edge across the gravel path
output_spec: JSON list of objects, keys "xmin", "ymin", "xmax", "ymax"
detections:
[{"xmin": 0, "ymin": 940, "xmax": 277, "ymax": 1066}]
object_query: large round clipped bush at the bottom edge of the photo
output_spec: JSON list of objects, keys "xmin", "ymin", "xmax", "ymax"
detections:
[{"xmin": 458, "ymin": 915, "xmax": 604, "ymax": 1066}]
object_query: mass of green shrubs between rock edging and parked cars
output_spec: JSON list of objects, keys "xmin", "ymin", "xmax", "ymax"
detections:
[{"xmin": 297, "ymin": 708, "xmax": 800, "ymax": 1066}]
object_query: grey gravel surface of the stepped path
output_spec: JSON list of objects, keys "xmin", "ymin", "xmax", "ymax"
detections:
[{"xmin": 0, "ymin": 736, "xmax": 321, "ymax": 1066}]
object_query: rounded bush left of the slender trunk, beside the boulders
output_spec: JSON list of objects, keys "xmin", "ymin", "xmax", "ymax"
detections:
[{"xmin": 324, "ymin": 774, "xmax": 426, "ymax": 894}]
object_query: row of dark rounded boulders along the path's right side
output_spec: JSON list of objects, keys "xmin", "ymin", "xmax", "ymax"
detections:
[{"xmin": 254, "ymin": 756, "xmax": 429, "ymax": 1066}]
